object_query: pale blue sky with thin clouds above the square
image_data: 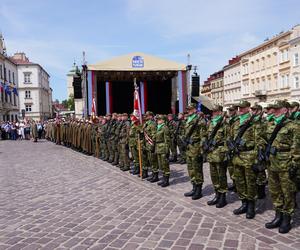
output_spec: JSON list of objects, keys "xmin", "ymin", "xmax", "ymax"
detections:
[{"xmin": 0, "ymin": 0, "xmax": 300, "ymax": 100}]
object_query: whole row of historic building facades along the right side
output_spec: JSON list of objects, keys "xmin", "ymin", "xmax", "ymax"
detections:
[{"xmin": 202, "ymin": 25, "xmax": 300, "ymax": 106}]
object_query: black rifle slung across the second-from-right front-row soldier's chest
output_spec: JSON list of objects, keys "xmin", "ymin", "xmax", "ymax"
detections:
[{"xmin": 227, "ymin": 113, "xmax": 256, "ymax": 160}]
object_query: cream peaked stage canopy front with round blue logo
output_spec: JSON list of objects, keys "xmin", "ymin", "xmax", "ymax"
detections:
[{"xmin": 88, "ymin": 52, "xmax": 186, "ymax": 71}]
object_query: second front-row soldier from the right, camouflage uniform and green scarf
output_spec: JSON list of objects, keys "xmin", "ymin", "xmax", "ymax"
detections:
[{"xmin": 232, "ymin": 101, "xmax": 257, "ymax": 219}]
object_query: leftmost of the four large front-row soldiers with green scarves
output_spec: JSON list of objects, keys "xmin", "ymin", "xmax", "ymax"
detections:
[{"xmin": 184, "ymin": 104, "xmax": 206, "ymax": 200}]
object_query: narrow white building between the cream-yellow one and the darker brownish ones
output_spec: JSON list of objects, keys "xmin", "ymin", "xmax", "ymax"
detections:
[{"xmin": 223, "ymin": 56, "xmax": 241, "ymax": 107}]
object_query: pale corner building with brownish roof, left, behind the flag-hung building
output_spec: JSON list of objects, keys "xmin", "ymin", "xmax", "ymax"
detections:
[{"xmin": 11, "ymin": 53, "xmax": 52, "ymax": 120}]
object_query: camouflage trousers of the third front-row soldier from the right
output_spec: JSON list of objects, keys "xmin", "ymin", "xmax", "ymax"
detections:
[{"xmin": 209, "ymin": 162, "xmax": 227, "ymax": 193}]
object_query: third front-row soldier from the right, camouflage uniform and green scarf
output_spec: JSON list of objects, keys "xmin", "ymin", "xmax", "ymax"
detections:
[{"xmin": 203, "ymin": 105, "xmax": 227, "ymax": 208}]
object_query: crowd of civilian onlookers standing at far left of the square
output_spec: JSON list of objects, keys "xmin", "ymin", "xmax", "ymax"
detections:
[{"xmin": 0, "ymin": 120, "xmax": 45, "ymax": 140}]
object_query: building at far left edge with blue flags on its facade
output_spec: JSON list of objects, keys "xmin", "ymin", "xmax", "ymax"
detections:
[{"xmin": 0, "ymin": 34, "xmax": 19, "ymax": 121}]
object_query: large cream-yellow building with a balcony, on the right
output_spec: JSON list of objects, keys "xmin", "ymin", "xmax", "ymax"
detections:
[{"xmin": 239, "ymin": 25, "xmax": 300, "ymax": 104}]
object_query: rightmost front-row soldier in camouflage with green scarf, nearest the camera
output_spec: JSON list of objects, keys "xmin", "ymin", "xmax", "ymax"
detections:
[{"xmin": 265, "ymin": 101, "xmax": 300, "ymax": 233}]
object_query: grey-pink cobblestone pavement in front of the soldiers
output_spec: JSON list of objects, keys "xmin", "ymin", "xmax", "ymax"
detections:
[{"xmin": 0, "ymin": 141, "xmax": 300, "ymax": 250}]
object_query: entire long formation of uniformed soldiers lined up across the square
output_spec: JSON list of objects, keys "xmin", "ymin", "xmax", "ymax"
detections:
[{"xmin": 45, "ymin": 100, "xmax": 300, "ymax": 233}]
